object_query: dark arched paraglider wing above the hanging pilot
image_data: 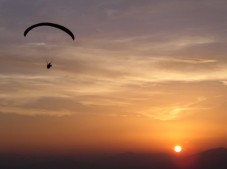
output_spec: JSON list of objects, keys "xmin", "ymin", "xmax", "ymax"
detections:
[{"xmin": 24, "ymin": 22, "xmax": 75, "ymax": 40}]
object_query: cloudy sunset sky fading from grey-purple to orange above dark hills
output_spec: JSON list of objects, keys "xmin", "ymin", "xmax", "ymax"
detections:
[{"xmin": 0, "ymin": 0, "xmax": 227, "ymax": 154}]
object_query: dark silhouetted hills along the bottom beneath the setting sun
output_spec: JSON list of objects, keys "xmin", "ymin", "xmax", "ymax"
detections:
[{"xmin": 0, "ymin": 148, "xmax": 227, "ymax": 169}]
